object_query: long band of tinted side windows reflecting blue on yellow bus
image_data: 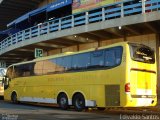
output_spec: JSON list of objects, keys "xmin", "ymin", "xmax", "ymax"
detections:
[{"xmin": 7, "ymin": 47, "xmax": 123, "ymax": 77}]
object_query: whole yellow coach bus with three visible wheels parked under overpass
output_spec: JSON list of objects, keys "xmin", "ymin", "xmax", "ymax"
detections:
[{"xmin": 4, "ymin": 42, "xmax": 157, "ymax": 111}]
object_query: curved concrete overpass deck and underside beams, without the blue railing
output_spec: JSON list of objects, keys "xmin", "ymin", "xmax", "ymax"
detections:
[{"xmin": 0, "ymin": 11, "xmax": 160, "ymax": 62}]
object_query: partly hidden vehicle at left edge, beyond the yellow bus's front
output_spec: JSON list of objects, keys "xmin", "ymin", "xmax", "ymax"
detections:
[{"xmin": 0, "ymin": 68, "xmax": 6, "ymax": 97}]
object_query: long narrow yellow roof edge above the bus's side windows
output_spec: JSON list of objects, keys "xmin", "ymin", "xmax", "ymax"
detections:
[{"xmin": 8, "ymin": 42, "xmax": 129, "ymax": 68}]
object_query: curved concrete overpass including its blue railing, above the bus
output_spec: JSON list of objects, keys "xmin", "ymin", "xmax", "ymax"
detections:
[{"xmin": 0, "ymin": 0, "xmax": 160, "ymax": 65}]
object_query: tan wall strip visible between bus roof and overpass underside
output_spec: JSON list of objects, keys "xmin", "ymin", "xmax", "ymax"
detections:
[{"xmin": 48, "ymin": 34, "xmax": 156, "ymax": 55}]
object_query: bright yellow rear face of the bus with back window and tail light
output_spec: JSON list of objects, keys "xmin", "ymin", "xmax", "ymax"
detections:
[{"xmin": 129, "ymin": 45, "xmax": 156, "ymax": 106}]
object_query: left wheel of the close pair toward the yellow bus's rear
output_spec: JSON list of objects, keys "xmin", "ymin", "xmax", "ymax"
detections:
[{"xmin": 58, "ymin": 94, "xmax": 68, "ymax": 110}]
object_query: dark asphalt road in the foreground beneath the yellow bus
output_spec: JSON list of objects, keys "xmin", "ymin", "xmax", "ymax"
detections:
[{"xmin": 0, "ymin": 100, "xmax": 160, "ymax": 120}]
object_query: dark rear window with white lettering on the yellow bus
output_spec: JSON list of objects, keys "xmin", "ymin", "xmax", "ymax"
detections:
[{"xmin": 129, "ymin": 43, "xmax": 155, "ymax": 64}]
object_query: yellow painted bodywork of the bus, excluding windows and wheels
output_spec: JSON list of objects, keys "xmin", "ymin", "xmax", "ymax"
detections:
[{"xmin": 4, "ymin": 42, "xmax": 157, "ymax": 107}]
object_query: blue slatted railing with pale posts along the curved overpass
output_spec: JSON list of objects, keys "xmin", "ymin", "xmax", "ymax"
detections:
[{"xmin": 0, "ymin": 0, "xmax": 160, "ymax": 51}]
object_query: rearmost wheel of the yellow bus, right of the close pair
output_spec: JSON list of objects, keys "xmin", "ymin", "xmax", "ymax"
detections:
[{"xmin": 73, "ymin": 94, "xmax": 85, "ymax": 111}]
